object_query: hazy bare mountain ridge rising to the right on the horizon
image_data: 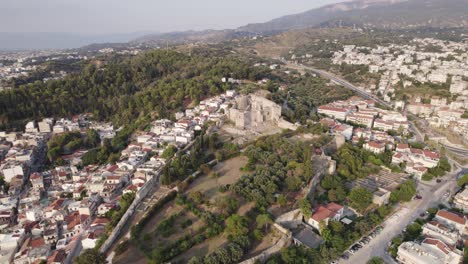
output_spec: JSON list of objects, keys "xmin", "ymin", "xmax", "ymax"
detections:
[{"xmin": 134, "ymin": 0, "xmax": 468, "ymax": 45}]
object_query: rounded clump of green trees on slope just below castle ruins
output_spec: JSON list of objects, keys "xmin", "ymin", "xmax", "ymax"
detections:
[{"xmin": 231, "ymin": 135, "xmax": 314, "ymax": 208}]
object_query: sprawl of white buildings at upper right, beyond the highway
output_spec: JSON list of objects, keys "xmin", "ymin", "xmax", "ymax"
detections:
[{"xmin": 333, "ymin": 38, "xmax": 468, "ymax": 140}]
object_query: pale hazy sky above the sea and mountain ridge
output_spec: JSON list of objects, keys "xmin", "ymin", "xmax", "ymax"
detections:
[{"xmin": 0, "ymin": 0, "xmax": 342, "ymax": 34}]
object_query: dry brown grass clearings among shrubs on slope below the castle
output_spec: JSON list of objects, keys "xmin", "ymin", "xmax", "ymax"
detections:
[{"xmin": 119, "ymin": 156, "xmax": 253, "ymax": 264}]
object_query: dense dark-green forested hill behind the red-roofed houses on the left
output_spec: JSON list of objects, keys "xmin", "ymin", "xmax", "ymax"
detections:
[{"xmin": 0, "ymin": 50, "xmax": 269, "ymax": 129}]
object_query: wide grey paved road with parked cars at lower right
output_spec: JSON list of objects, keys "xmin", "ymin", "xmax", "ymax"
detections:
[{"xmin": 339, "ymin": 169, "xmax": 462, "ymax": 264}]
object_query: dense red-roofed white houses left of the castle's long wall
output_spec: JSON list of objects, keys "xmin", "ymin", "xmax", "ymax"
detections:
[{"xmin": 0, "ymin": 87, "xmax": 249, "ymax": 263}]
